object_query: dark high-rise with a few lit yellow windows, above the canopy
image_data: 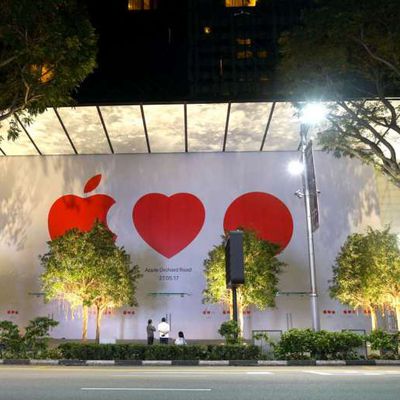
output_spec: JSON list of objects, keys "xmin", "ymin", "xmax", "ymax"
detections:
[{"xmin": 188, "ymin": 0, "xmax": 310, "ymax": 99}]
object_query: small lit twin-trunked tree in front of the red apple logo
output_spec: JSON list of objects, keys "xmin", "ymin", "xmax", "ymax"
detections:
[{"xmin": 41, "ymin": 221, "xmax": 142, "ymax": 342}]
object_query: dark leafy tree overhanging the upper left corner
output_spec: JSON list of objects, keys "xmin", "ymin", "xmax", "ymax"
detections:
[{"xmin": 0, "ymin": 0, "xmax": 96, "ymax": 139}]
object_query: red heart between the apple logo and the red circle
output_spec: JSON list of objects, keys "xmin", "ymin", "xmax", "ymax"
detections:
[{"xmin": 132, "ymin": 193, "xmax": 205, "ymax": 258}]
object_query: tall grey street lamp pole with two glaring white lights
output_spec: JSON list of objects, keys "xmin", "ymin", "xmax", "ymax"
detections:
[{"xmin": 289, "ymin": 103, "xmax": 327, "ymax": 331}]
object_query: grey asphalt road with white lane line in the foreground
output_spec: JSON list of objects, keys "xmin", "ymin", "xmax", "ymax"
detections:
[{"xmin": 0, "ymin": 365, "xmax": 400, "ymax": 400}]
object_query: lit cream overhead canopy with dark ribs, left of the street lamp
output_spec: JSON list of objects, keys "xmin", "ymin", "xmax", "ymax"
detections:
[{"xmin": 0, "ymin": 102, "xmax": 306, "ymax": 156}]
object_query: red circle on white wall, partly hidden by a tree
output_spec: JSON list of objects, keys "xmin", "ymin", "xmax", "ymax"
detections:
[{"xmin": 224, "ymin": 192, "xmax": 293, "ymax": 251}]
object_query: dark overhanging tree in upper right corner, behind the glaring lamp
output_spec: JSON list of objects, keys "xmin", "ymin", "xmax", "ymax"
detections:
[{"xmin": 279, "ymin": 0, "xmax": 400, "ymax": 186}]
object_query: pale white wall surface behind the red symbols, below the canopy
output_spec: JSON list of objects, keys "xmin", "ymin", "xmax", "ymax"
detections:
[{"xmin": 0, "ymin": 152, "xmax": 381, "ymax": 339}]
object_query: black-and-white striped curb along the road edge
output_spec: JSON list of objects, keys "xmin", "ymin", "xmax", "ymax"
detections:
[{"xmin": 0, "ymin": 359, "xmax": 400, "ymax": 367}]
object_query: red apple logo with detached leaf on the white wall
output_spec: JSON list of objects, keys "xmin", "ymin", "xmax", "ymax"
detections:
[{"xmin": 48, "ymin": 174, "xmax": 115, "ymax": 239}]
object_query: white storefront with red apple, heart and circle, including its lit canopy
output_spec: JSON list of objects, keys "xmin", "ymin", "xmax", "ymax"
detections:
[{"xmin": 0, "ymin": 103, "xmax": 400, "ymax": 340}]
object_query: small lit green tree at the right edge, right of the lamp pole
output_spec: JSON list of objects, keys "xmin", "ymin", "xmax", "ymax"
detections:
[{"xmin": 330, "ymin": 228, "xmax": 400, "ymax": 330}]
